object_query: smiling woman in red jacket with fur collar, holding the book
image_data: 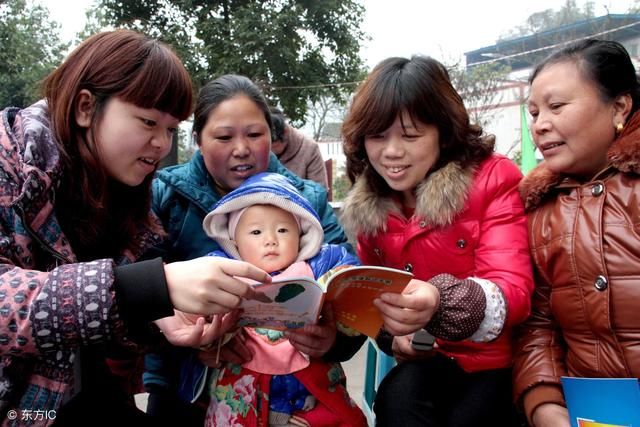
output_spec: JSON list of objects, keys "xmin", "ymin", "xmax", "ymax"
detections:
[{"xmin": 342, "ymin": 56, "xmax": 533, "ymax": 426}]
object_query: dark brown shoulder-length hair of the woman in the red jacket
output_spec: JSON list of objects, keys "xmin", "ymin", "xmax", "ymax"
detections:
[{"xmin": 342, "ymin": 56, "xmax": 495, "ymax": 194}]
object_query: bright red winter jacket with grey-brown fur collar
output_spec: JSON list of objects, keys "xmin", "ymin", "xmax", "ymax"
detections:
[{"xmin": 342, "ymin": 154, "xmax": 533, "ymax": 372}]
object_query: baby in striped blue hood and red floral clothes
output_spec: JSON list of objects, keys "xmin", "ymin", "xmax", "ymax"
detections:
[{"xmin": 194, "ymin": 173, "xmax": 367, "ymax": 427}]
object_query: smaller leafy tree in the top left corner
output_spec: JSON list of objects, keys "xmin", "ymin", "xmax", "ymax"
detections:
[{"xmin": 0, "ymin": 0, "xmax": 69, "ymax": 108}]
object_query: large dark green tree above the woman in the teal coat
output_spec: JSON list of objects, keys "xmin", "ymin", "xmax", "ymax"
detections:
[{"xmin": 94, "ymin": 0, "xmax": 365, "ymax": 126}]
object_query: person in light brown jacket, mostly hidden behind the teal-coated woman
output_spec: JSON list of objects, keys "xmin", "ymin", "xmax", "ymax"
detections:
[{"xmin": 271, "ymin": 108, "xmax": 329, "ymax": 188}]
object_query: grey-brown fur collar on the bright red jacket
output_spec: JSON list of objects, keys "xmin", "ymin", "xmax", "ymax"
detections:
[{"xmin": 340, "ymin": 162, "xmax": 476, "ymax": 236}]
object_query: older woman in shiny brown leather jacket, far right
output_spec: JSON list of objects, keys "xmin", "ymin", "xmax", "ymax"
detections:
[{"xmin": 514, "ymin": 39, "xmax": 640, "ymax": 427}]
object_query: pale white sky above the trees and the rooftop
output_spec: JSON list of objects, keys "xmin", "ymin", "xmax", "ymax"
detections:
[{"xmin": 39, "ymin": 0, "xmax": 633, "ymax": 68}]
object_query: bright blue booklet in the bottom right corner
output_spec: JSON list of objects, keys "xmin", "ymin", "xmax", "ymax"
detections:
[{"xmin": 561, "ymin": 377, "xmax": 640, "ymax": 427}]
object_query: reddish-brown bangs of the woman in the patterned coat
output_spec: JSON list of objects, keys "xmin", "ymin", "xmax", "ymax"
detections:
[{"xmin": 119, "ymin": 44, "xmax": 193, "ymax": 121}]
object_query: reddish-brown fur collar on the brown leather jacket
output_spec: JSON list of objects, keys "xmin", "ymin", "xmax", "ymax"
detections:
[{"xmin": 520, "ymin": 112, "xmax": 640, "ymax": 211}]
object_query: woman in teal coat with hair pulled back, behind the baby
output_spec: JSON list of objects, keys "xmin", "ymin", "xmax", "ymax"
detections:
[{"xmin": 144, "ymin": 74, "xmax": 362, "ymax": 427}]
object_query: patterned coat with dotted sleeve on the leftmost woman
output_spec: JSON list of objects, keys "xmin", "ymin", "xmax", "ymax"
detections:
[{"xmin": 0, "ymin": 101, "xmax": 164, "ymax": 425}]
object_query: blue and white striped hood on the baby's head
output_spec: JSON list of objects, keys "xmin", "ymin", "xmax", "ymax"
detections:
[{"xmin": 202, "ymin": 172, "xmax": 324, "ymax": 261}]
